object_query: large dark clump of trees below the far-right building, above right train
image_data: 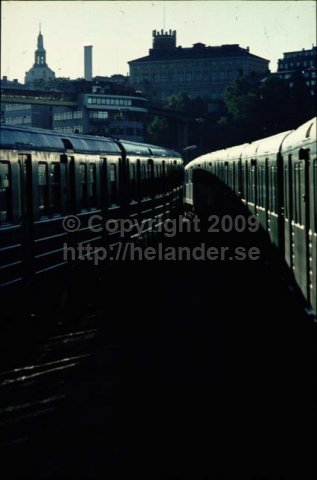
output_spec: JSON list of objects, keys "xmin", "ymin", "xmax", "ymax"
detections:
[{"xmin": 218, "ymin": 73, "xmax": 316, "ymax": 142}]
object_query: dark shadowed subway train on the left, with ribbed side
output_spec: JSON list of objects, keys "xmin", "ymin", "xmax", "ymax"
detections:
[{"xmin": 0, "ymin": 125, "xmax": 184, "ymax": 306}]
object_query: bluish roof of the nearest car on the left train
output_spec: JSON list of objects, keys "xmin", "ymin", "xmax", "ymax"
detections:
[{"xmin": 0, "ymin": 125, "xmax": 120, "ymax": 153}]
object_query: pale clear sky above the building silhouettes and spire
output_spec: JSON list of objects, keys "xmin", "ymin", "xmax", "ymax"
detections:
[{"xmin": 1, "ymin": 0, "xmax": 316, "ymax": 83}]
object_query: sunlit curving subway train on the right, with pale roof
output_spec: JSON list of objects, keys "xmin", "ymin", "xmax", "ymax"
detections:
[{"xmin": 184, "ymin": 118, "xmax": 317, "ymax": 315}]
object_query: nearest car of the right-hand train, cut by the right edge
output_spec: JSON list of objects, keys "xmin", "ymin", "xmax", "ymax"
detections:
[{"xmin": 281, "ymin": 118, "xmax": 317, "ymax": 313}]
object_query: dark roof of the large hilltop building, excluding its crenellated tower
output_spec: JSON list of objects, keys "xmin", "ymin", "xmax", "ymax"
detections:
[{"xmin": 128, "ymin": 43, "xmax": 269, "ymax": 64}]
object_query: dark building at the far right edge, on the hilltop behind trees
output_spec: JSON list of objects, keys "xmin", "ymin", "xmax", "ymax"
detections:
[{"xmin": 277, "ymin": 46, "xmax": 317, "ymax": 95}]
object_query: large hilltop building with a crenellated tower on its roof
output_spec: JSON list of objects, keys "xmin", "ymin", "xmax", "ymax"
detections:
[{"xmin": 129, "ymin": 30, "xmax": 269, "ymax": 103}]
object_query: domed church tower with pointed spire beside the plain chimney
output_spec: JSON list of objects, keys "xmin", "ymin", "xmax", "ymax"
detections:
[{"xmin": 25, "ymin": 30, "xmax": 55, "ymax": 88}]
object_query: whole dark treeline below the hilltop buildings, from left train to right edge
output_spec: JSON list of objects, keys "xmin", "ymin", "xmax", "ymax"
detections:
[{"xmin": 144, "ymin": 74, "xmax": 317, "ymax": 156}]
